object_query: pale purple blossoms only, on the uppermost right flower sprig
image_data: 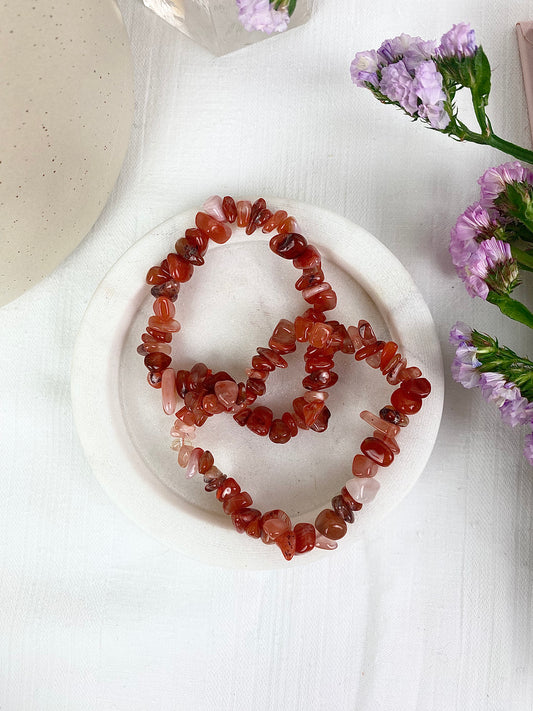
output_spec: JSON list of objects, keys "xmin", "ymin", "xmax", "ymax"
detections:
[{"xmin": 350, "ymin": 22, "xmax": 477, "ymax": 130}]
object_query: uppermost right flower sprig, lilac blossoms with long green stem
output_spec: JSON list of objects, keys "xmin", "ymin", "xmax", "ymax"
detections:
[{"xmin": 350, "ymin": 22, "xmax": 533, "ymax": 163}]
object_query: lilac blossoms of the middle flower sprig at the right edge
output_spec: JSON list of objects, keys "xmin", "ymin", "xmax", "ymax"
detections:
[{"xmin": 450, "ymin": 162, "xmax": 520, "ymax": 299}]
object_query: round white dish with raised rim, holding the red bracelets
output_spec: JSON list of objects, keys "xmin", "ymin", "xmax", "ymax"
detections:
[{"xmin": 72, "ymin": 198, "xmax": 444, "ymax": 568}]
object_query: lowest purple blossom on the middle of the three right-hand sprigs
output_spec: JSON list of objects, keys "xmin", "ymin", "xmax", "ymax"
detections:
[{"xmin": 463, "ymin": 237, "xmax": 518, "ymax": 299}]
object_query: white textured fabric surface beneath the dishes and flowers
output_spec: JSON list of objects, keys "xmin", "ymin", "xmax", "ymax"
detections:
[{"xmin": 0, "ymin": 0, "xmax": 533, "ymax": 711}]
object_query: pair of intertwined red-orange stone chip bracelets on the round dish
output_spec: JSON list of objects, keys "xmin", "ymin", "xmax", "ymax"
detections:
[{"xmin": 138, "ymin": 196, "xmax": 431, "ymax": 560}]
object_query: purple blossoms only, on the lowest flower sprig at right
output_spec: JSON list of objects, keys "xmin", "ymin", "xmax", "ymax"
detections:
[{"xmin": 450, "ymin": 322, "xmax": 533, "ymax": 466}]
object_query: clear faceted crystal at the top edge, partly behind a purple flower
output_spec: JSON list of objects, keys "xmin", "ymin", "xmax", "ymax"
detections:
[{"xmin": 143, "ymin": 0, "xmax": 315, "ymax": 56}]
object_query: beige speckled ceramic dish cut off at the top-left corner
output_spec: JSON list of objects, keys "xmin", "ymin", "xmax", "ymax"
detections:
[{"xmin": 0, "ymin": 0, "xmax": 133, "ymax": 305}]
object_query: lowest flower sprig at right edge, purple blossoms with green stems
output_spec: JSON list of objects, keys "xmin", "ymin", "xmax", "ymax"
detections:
[{"xmin": 450, "ymin": 322, "xmax": 533, "ymax": 466}]
